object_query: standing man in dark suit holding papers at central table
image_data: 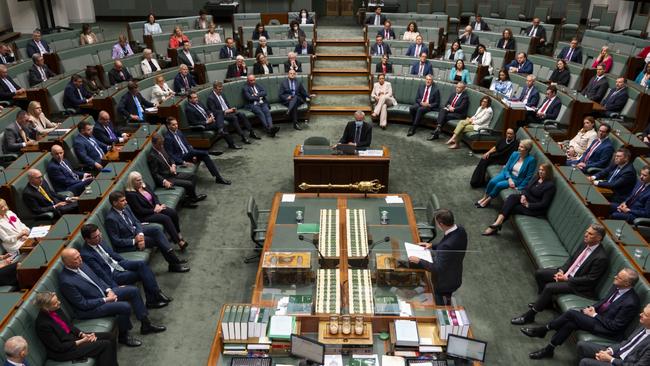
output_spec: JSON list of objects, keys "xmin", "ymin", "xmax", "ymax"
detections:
[{"xmin": 409, "ymin": 209, "xmax": 467, "ymax": 306}]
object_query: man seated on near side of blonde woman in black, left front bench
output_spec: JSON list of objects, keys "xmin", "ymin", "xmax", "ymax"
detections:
[{"xmin": 104, "ymin": 191, "xmax": 190, "ymax": 273}]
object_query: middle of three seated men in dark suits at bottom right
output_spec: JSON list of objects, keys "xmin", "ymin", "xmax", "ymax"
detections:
[{"xmin": 521, "ymin": 268, "xmax": 640, "ymax": 360}]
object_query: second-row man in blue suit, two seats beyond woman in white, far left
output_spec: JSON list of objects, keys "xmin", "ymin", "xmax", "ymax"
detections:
[{"xmin": 47, "ymin": 145, "xmax": 94, "ymax": 196}]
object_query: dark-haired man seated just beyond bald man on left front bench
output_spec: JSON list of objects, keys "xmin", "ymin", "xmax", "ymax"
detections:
[{"xmin": 79, "ymin": 224, "xmax": 172, "ymax": 309}]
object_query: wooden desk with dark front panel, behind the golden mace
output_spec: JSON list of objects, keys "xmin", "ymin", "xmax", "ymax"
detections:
[{"xmin": 293, "ymin": 145, "xmax": 390, "ymax": 192}]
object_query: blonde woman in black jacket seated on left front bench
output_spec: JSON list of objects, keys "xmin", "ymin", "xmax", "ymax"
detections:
[{"xmin": 126, "ymin": 172, "xmax": 189, "ymax": 251}]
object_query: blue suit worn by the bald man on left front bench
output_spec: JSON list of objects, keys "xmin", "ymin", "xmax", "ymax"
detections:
[{"xmin": 59, "ymin": 263, "xmax": 148, "ymax": 336}]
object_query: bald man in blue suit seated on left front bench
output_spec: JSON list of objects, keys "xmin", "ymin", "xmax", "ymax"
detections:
[{"xmin": 59, "ymin": 248, "xmax": 167, "ymax": 347}]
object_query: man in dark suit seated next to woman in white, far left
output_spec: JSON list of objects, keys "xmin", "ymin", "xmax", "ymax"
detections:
[{"xmin": 23, "ymin": 169, "xmax": 79, "ymax": 219}]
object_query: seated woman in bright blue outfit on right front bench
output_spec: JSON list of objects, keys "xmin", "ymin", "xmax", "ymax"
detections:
[{"xmin": 474, "ymin": 140, "xmax": 537, "ymax": 208}]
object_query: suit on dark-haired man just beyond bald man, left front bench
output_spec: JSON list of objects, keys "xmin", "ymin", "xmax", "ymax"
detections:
[{"xmin": 79, "ymin": 242, "xmax": 160, "ymax": 302}]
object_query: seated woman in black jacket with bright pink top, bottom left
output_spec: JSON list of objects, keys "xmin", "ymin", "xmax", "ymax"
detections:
[{"xmin": 36, "ymin": 292, "xmax": 118, "ymax": 366}]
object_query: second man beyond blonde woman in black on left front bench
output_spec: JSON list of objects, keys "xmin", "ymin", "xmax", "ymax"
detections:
[{"xmin": 164, "ymin": 117, "xmax": 229, "ymax": 184}]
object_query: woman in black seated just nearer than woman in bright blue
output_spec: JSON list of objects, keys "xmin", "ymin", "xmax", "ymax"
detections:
[{"xmin": 483, "ymin": 163, "xmax": 555, "ymax": 236}]
